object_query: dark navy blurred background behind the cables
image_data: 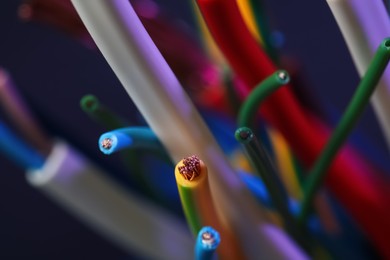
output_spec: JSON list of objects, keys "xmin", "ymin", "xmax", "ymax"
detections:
[{"xmin": 0, "ymin": 0, "xmax": 390, "ymax": 259}]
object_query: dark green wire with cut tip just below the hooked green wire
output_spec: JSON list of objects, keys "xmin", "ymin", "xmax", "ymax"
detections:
[{"xmin": 235, "ymin": 127, "xmax": 312, "ymax": 252}]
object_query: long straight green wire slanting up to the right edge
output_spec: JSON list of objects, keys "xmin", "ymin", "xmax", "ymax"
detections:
[{"xmin": 298, "ymin": 38, "xmax": 390, "ymax": 226}]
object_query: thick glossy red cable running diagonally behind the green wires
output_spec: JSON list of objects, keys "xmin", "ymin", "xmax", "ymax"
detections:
[{"xmin": 197, "ymin": 0, "xmax": 390, "ymax": 258}]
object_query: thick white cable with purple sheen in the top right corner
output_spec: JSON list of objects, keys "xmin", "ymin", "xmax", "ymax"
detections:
[{"xmin": 327, "ymin": 0, "xmax": 390, "ymax": 149}]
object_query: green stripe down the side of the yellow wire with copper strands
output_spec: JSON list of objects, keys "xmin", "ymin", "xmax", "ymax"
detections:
[{"xmin": 178, "ymin": 185, "xmax": 202, "ymax": 237}]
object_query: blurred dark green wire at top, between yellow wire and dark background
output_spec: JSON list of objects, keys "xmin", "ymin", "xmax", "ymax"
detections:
[{"xmin": 249, "ymin": 0, "xmax": 278, "ymax": 62}]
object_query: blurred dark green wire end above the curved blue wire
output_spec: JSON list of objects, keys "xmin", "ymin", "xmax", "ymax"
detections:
[{"xmin": 80, "ymin": 95, "xmax": 126, "ymax": 130}]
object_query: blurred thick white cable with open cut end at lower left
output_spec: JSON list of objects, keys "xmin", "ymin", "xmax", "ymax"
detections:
[{"xmin": 27, "ymin": 143, "xmax": 195, "ymax": 260}]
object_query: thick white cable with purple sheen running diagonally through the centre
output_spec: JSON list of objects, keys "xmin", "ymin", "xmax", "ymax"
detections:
[{"xmin": 72, "ymin": 0, "xmax": 306, "ymax": 259}]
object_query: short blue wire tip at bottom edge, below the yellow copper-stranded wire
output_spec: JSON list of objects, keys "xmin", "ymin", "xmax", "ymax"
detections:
[{"xmin": 195, "ymin": 227, "xmax": 221, "ymax": 260}]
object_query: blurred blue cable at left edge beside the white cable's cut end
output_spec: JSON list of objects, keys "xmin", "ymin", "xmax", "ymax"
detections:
[{"xmin": 0, "ymin": 122, "xmax": 45, "ymax": 170}]
